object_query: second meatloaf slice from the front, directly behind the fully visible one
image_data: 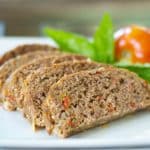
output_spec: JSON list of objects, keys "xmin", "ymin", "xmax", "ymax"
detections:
[{"xmin": 23, "ymin": 61, "xmax": 105, "ymax": 129}]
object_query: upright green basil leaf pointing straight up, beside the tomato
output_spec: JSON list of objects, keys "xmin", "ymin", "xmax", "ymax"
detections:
[{"xmin": 94, "ymin": 14, "xmax": 114, "ymax": 63}]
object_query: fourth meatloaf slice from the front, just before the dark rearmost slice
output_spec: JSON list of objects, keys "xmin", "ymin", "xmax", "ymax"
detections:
[{"xmin": 0, "ymin": 51, "xmax": 60, "ymax": 101}]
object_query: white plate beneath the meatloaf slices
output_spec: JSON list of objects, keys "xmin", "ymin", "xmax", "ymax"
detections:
[{"xmin": 0, "ymin": 38, "xmax": 150, "ymax": 148}]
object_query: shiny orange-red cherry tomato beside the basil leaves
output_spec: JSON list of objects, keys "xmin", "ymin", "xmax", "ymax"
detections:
[{"xmin": 115, "ymin": 25, "xmax": 150, "ymax": 63}]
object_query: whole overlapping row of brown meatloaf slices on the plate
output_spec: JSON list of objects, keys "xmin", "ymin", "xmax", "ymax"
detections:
[{"xmin": 0, "ymin": 44, "xmax": 150, "ymax": 137}]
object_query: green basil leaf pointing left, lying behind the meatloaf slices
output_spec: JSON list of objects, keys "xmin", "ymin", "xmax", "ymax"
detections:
[{"xmin": 44, "ymin": 27, "xmax": 95, "ymax": 59}]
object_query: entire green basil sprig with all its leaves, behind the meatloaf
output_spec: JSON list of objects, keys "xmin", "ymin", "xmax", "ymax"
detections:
[{"xmin": 44, "ymin": 14, "xmax": 150, "ymax": 81}]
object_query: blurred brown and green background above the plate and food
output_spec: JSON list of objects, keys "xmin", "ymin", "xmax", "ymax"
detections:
[{"xmin": 0, "ymin": 0, "xmax": 150, "ymax": 36}]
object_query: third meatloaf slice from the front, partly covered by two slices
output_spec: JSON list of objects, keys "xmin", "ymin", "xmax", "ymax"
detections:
[{"xmin": 2, "ymin": 54, "xmax": 87, "ymax": 111}]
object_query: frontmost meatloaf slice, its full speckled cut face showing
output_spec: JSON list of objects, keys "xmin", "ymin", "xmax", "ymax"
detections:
[{"xmin": 47, "ymin": 68, "xmax": 150, "ymax": 137}]
